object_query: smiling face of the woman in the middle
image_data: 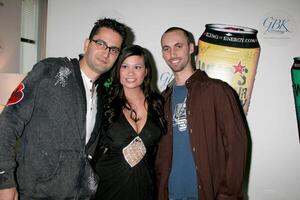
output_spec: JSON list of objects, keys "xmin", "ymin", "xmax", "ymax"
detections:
[{"xmin": 120, "ymin": 55, "xmax": 147, "ymax": 90}]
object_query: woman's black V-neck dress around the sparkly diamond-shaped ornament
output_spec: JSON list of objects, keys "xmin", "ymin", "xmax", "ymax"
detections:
[{"xmin": 95, "ymin": 114, "xmax": 162, "ymax": 200}]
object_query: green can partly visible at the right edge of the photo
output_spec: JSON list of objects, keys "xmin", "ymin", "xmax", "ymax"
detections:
[{"xmin": 291, "ymin": 57, "xmax": 300, "ymax": 134}]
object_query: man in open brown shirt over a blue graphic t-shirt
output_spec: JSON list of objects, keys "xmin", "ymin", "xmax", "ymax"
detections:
[{"xmin": 155, "ymin": 27, "xmax": 247, "ymax": 200}]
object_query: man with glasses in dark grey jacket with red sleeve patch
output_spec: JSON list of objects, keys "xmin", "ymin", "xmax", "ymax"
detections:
[{"xmin": 0, "ymin": 18, "xmax": 127, "ymax": 200}]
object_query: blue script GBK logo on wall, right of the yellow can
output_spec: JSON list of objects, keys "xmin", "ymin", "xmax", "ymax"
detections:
[{"xmin": 263, "ymin": 17, "xmax": 290, "ymax": 34}]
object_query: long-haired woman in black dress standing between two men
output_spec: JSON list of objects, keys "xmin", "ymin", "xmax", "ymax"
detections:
[{"xmin": 95, "ymin": 45, "xmax": 166, "ymax": 200}]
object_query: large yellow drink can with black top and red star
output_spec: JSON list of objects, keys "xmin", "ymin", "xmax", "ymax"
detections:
[{"xmin": 196, "ymin": 24, "xmax": 260, "ymax": 114}]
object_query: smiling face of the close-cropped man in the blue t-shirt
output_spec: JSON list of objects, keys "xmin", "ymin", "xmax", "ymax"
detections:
[{"xmin": 161, "ymin": 30, "xmax": 194, "ymax": 73}]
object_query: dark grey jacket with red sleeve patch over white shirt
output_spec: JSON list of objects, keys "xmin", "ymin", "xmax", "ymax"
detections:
[{"xmin": 0, "ymin": 58, "xmax": 102, "ymax": 199}]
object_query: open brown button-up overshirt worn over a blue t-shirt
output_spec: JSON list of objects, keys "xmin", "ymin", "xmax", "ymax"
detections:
[{"xmin": 155, "ymin": 70, "xmax": 247, "ymax": 200}]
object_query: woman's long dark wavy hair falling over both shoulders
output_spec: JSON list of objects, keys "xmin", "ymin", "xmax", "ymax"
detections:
[{"xmin": 102, "ymin": 45, "xmax": 166, "ymax": 133}]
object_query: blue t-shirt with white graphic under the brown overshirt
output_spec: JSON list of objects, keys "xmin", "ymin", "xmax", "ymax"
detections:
[{"xmin": 169, "ymin": 85, "xmax": 198, "ymax": 200}]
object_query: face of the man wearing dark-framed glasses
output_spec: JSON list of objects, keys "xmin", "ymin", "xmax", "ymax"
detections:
[{"xmin": 83, "ymin": 27, "xmax": 123, "ymax": 78}]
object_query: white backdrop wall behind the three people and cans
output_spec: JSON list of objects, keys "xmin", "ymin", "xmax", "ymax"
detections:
[{"xmin": 47, "ymin": 0, "xmax": 300, "ymax": 200}]
